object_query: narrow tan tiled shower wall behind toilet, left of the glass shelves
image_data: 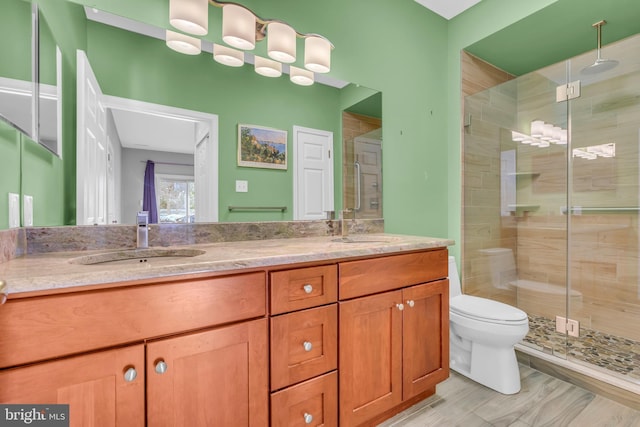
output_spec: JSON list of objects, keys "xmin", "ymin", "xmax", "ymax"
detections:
[{"xmin": 461, "ymin": 52, "xmax": 517, "ymax": 304}]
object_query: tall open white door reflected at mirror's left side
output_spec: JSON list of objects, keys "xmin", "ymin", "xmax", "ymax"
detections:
[{"xmin": 76, "ymin": 50, "xmax": 107, "ymax": 225}]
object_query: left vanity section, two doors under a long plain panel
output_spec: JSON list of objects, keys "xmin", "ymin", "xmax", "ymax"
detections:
[{"xmin": 0, "ymin": 272, "xmax": 269, "ymax": 427}]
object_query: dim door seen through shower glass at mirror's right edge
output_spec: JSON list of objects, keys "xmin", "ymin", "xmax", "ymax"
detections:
[{"xmin": 353, "ymin": 137, "xmax": 382, "ymax": 218}]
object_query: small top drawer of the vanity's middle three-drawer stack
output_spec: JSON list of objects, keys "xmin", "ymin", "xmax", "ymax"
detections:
[{"xmin": 270, "ymin": 264, "xmax": 338, "ymax": 314}]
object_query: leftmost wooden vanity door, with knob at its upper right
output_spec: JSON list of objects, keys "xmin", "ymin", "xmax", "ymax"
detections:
[{"xmin": 0, "ymin": 344, "xmax": 145, "ymax": 427}]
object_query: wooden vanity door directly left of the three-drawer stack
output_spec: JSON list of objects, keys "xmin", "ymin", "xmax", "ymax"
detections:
[{"xmin": 147, "ymin": 319, "xmax": 269, "ymax": 427}]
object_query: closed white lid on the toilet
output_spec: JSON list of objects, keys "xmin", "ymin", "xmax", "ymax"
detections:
[{"xmin": 449, "ymin": 295, "xmax": 527, "ymax": 324}]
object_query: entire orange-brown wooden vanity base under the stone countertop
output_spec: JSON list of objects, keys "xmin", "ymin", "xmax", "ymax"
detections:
[{"xmin": 0, "ymin": 242, "xmax": 449, "ymax": 427}]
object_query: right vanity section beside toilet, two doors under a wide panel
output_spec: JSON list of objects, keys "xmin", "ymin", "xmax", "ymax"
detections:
[{"xmin": 339, "ymin": 250, "xmax": 449, "ymax": 427}]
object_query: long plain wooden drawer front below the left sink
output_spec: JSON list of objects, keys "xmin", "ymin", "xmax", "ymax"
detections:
[{"xmin": 0, "ymin": 272, "xmax": 267, "ymax": 368}]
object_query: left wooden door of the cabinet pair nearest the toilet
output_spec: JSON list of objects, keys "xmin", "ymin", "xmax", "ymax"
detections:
[{"xmin": 339, "ymin": 291, "xmax": 402, "ymax": 427}]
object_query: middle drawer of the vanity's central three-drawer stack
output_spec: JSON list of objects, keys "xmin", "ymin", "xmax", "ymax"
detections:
[{"xmin": 271, "ymin": 304, "xmax": 338, "ymax": 390}]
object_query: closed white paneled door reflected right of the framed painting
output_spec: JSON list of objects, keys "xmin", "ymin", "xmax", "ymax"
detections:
[{"xmin": 293, "ymin": 126, "xmax": 334, "ymax": 220}]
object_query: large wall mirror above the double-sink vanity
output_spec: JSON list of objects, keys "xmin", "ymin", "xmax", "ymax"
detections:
[{"xmin": 1, "ymin": 0, "xmax": 382, "ymax": 229}]
